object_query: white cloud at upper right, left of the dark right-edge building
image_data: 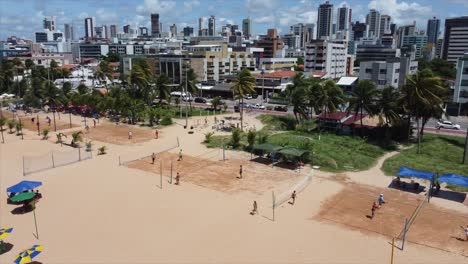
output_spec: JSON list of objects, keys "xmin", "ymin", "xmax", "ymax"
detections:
[{"xmin": 368, "ymin": 0, "xmax": 433, "ymax": 27}]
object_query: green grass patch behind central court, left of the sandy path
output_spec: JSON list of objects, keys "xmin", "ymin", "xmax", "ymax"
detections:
[{"xmin": 268, "ymin": 132, "xmax": 385, "ymax": 172}]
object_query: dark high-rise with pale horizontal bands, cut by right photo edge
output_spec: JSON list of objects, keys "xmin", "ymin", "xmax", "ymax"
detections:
[{"xmin": 442, "ymin": 16, "xmax": 468, "ymax": 64}]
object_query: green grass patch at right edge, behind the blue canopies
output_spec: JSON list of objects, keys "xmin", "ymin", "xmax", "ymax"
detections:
[{"xmin": 382, "ymin": 134, "xmax": 468, "ymax": 191}]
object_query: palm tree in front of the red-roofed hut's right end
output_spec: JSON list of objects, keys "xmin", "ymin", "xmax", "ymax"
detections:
[{"xmin": 348, "ymin": 80, "xmax": 379, "ymax": 137}]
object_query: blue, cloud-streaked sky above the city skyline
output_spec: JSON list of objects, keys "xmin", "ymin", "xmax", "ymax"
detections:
[{"xmin": 0, "ymin": 0, "xmax": 468, "ymax": 40}]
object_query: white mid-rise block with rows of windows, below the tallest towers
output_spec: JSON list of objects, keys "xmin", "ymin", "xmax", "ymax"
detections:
[{"xmin": 304, "ymin": 40, "xmax": 348, "ymax": 79}]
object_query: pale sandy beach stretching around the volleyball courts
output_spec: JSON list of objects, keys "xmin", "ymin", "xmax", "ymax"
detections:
[{"xmin": 0, "ymin": 111, "xmax": 468, "ymax": 263}]
